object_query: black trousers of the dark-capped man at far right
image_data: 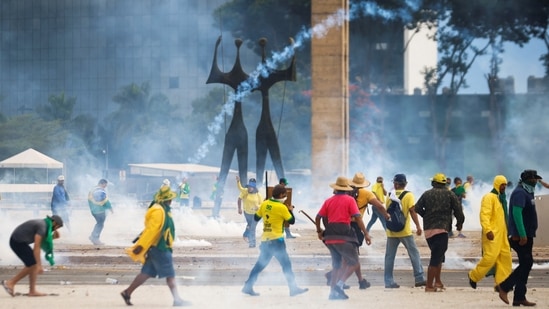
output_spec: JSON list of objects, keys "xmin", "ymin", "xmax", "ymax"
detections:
[{"xmin": 499, "ymin": 237, "xmax": 534, "ymax": 302}]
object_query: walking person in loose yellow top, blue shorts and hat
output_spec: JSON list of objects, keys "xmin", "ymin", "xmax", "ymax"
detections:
[{"xmin": 120, "ymin": 185, "xmax": 190, "ymax": 307}]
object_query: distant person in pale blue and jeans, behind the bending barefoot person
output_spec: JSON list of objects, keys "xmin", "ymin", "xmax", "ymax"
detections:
[{"xmin": 88, "ymin": 179, "xmax": 113, "ymax": 246}]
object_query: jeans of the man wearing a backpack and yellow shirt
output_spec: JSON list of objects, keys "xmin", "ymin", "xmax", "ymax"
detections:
[{"xmin": 384, "ymin": 235, "xmax": 425, "ymax": 286}]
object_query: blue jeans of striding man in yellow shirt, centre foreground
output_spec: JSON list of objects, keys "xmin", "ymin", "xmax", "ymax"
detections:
[{"xmin": 246, "ymin": 238, "xmax": 297, "ymax": 289}]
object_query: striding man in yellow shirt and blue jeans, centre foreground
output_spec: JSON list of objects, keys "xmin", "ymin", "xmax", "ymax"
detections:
[{"xmin": 242, "ymin": 185, "xmax": 309, "ymax": 296}]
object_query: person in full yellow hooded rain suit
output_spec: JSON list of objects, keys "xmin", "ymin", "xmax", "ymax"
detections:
[{"xmin": 469, "ymin": 175, "xmax": 512, "ymax": 300}]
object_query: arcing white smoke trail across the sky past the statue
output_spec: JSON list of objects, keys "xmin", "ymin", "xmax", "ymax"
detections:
[{"xmin": 189, "ymin": 0, "xmax": 421, "ymax": 163}]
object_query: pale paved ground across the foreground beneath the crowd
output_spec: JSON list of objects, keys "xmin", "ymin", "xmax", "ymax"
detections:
[{"xmin": 0, "ymin": 205, "xmax": 549, "ymax": 308}]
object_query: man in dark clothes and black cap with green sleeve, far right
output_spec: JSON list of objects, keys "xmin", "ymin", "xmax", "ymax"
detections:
[{"xmin": 498, "ymin": 170, "xmax": 542, "ymax": 306}]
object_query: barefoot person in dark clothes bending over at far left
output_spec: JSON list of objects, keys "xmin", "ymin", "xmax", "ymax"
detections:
[{"xmin": 2, "ymin": 215, "xmax": 63, "ymax": 296}]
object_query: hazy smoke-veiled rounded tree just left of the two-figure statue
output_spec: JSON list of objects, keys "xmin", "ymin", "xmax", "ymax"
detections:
[{"xmin": 105, "ymin": 82, "xmax": 184, "ymax": 168}]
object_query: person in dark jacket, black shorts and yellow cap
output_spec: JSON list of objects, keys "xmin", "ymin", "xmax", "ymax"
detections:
[{"xmin": 415, "ymin": 173, "xmax": 465, "ymax": 292}]
